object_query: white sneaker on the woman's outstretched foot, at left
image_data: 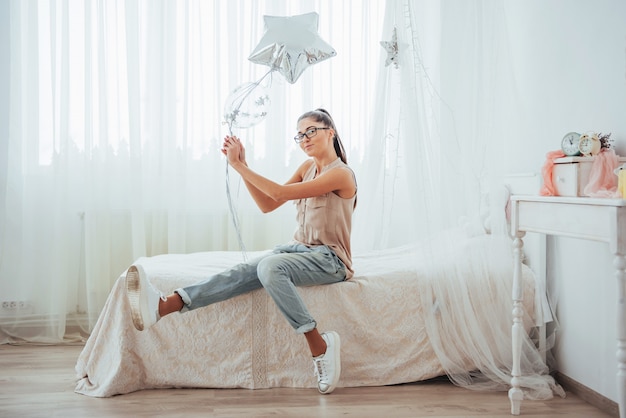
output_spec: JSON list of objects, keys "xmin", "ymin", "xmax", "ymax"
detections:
[{"xmin": 126, "ymin": 265, "xmax": 166, "ymax": 331}]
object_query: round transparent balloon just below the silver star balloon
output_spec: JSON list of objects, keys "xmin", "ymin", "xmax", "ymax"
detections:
[{"xmin": 224, "ymin": 82, "xmax": 271, "ymax": 128}]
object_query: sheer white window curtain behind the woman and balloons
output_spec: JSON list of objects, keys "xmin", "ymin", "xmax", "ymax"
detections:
[{"xmin": 0, "ymin": 0, "xmax": 384, "ymax": 343}]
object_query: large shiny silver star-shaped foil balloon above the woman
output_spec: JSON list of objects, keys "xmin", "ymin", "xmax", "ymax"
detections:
[{"xmin": 248, "ymin": 12, "xmax": 337, "ymax": 84}]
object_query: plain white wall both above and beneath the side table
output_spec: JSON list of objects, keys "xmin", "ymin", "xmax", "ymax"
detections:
[{"xmin": 496, "ymin": 0, "xmax": 626, "ymax": 402}]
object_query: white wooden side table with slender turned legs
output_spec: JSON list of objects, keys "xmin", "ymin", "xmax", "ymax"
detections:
[{"xmin": 509, "ymin": 196, "xmax": 626, "ymax": 418}]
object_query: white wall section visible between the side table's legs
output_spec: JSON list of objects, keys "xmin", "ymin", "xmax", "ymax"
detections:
[{"xmin": 548, "ymin": 238, "xmax": 617, "ymax": 402}]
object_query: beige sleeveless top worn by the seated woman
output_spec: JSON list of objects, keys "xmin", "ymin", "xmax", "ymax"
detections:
[{"xmin": 294, "ymin": 158, "xmax": 356, "ymax": 279}]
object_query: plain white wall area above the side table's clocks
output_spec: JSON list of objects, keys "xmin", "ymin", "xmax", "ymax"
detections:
[{"xmin": 506, "ymin": 0, "xmax": 626, "ymax": 160}]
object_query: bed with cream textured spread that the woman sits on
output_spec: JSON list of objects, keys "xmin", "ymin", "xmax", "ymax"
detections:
[{"xmin": 75, "ymin": 175, "xmax": 555, "ymax": 399}]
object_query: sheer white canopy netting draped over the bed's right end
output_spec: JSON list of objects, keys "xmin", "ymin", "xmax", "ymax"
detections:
[{"xmin": 355, "ymin": 0, "xmax": 564, "ymax": 399}]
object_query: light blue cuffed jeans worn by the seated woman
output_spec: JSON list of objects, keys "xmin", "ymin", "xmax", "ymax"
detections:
[{"xmin": 176, "ymin": 244, "xmax": 346, "ymax": 333}]
